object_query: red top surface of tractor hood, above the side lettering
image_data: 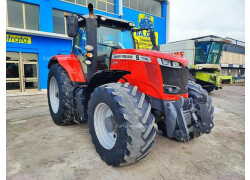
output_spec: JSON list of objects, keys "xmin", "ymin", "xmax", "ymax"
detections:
[{"xmin": 113, "ymin": 49, "xmax": 189, "ymax": 67}]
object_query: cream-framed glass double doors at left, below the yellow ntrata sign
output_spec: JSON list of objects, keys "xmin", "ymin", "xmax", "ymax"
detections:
[{"xmin": 6, "ymin": 52, "xmax": 39, "ymax": 92}]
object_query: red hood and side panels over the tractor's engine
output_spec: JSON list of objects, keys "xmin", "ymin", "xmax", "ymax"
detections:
[{"xmin": 110, "ymin": 49, "xmax": 188, "ymax": 100}]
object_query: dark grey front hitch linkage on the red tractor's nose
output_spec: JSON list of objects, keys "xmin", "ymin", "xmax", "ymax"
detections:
[{"xmin": 163, "ymin": 97, "xmax": 214, "ymax": 143}]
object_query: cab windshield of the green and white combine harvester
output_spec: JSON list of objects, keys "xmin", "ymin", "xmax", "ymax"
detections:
[{"xmin": 195, "ymin": 41, "xmax": 223, "ymax": 64}]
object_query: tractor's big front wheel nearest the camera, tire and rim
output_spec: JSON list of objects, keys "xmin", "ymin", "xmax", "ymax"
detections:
[{"xmin": 88, "ymin": 83, "xmax": 156, "ymax": 166}]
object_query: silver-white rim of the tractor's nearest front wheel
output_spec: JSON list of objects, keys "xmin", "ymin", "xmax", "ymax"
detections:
[{"xmin": 94, "ymin": 103, "xmax": 117, "ymax": 149}]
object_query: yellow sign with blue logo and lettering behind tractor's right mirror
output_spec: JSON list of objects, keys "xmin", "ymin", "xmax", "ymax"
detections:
[{"xmin": 134, "ymin": 14, "xmax": 158, "ymax": 50}]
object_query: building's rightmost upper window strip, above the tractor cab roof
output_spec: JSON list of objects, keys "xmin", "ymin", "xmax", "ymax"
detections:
[{"xmin": 123, "ymin": 0, "xmax": 162, "ymax": 17}]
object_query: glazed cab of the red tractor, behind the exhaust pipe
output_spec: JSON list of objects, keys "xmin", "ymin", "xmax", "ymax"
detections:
[{"xmin": 72, "ymin": 15, "xmax": 134, "ymax": 75}]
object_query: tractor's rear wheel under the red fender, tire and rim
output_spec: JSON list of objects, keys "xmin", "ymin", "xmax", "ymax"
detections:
[{"xmin": 47, "ymin": 64, "xmax": 74, "ymax": 126}]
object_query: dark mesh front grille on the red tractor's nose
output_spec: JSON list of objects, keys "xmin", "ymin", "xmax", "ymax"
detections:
[{"xmin": 160, "ymin": 66, "xmax": 189, "ymax": 94}]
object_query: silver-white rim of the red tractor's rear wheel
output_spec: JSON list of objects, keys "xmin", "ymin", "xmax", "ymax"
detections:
[{"xmin": 49, "ymin": 77, "xmax": 59, "ymax": 113}]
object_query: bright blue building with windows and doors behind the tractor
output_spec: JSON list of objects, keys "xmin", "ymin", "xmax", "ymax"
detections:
[{"xmin": 6, "ymin": 0, "xmax": 169, "ymax": 91}]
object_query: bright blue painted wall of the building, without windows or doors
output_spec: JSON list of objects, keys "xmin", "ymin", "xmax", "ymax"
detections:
[{"xmin": 6, "ymin": 0, "xmax": 167, "ymax": 89}]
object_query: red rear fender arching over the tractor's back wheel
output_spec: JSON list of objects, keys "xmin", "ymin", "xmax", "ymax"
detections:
[{"xmin": 48, "ymin": 54, "xmax": 87, "ymax": 82}]
